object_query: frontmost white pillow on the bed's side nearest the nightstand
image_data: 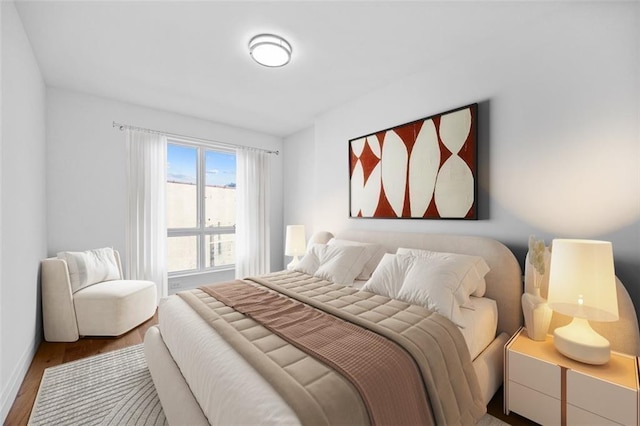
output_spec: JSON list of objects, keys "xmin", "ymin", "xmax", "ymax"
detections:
[{"xmin": 397, "ymin": 255, "xmax": 464, "ymax": 328}]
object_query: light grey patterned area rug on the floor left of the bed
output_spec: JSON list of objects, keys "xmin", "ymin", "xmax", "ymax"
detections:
[{"xmin": 29, "ymin": 344, "xmax": 168, "ymax": 426}]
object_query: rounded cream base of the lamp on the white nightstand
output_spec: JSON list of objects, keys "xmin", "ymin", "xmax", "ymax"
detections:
[{"xmin": 553, "ymin": 318, "xmax": 611, "ymax": 365}]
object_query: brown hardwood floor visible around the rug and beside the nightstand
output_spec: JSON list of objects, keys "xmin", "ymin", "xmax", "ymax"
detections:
[{"xmin": 4, "ymin": 314, "xmax": 535, "ymax": 426}]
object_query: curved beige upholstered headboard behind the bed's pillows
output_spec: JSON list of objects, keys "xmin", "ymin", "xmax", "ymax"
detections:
[{"xmin": 330, "ymin": 230, "xmax": 523, "ymax": 335}]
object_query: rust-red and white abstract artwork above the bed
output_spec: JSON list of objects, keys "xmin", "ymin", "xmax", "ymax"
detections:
[{"xmin": 349, "ymin": 104, "xmax": 478, "ymax": 219}]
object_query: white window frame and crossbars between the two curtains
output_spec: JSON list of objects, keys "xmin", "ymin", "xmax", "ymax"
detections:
[{"xmin": 165, "ymin": 137, "xmax": 237, "ymax": 278}]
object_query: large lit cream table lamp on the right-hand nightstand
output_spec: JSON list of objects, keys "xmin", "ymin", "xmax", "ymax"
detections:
[{"xmin": 547, "ymin": 239, "xmax": 618, "ymax": 365}]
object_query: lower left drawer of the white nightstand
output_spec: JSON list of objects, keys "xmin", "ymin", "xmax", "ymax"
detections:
[{"xmin": 509, "ymin": 381, "xmax": 560, "ymax": 425}]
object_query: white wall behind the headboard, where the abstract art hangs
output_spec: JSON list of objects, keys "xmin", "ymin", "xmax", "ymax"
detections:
[{"xmin": 285, "ymin": 2, "xmax": 640, "ymax": 307}]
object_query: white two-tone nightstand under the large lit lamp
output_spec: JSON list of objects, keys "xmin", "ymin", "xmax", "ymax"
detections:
[{"xmin": 504, "ymin": 328, "xmax": 640, "ymax": 425}]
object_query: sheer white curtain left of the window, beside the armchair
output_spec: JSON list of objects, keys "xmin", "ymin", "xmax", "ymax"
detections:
[{"xmin": 126, "ymin": 130, "xmax": 167, "ymax": 297}]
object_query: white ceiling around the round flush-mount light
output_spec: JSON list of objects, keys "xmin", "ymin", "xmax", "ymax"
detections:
[{"xmin": 16, "ymin": 0, "xmax": 558, "ymax": 136}]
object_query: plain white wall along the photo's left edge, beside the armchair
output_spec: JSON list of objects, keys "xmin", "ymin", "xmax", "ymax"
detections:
[{"xmin": 0, "ymin": 2, "xmax": 46, "ymax": 421}]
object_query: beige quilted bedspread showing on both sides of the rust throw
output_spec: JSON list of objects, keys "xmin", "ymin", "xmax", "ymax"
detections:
[{"xmin": 179, "ymin": 271, "xmax": 485, "ymax": 424}]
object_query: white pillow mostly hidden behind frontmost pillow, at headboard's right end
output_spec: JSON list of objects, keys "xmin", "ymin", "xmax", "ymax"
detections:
[{"xmin": 396, "ymin": 247, "xmax": 490, "ymax": 298}]
